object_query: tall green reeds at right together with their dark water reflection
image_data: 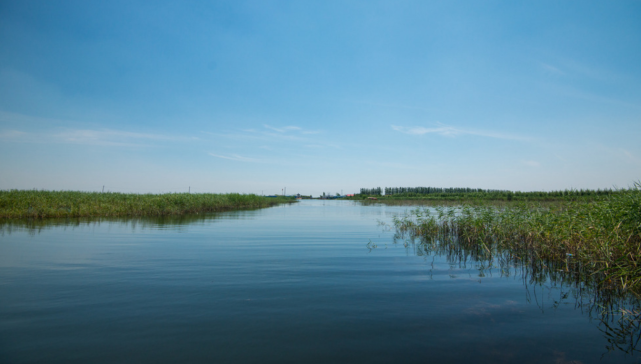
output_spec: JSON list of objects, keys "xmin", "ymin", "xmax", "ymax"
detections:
[{"xmin": 390, "ymin": 184, "xmax": 641, "ymax": 355}]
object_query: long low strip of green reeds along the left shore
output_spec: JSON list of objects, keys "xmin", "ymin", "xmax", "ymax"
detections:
[{"xmin": 0, "ymin": 190, "xmax": 294, "ymax": 219}]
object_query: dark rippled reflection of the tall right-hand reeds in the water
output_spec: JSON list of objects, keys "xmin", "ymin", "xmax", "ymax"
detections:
[{"xmin": 388, "ymin": 223, "xmax": 641, "ymax": 356}]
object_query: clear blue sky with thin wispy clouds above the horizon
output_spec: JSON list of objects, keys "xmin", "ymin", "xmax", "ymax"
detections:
[{"xmin": 0, "ymin": 0, "xmax": 641, "ymax": 196}]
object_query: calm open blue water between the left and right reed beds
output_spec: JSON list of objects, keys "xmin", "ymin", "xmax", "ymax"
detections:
[{"xmin": 0, "ymin": 201, "xmax": 641, "ymax": 363}]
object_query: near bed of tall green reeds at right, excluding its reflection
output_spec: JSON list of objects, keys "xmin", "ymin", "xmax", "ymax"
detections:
[{"xmin": 395, "ymin": 184, "xmax": 641, "ymax": 294}]
